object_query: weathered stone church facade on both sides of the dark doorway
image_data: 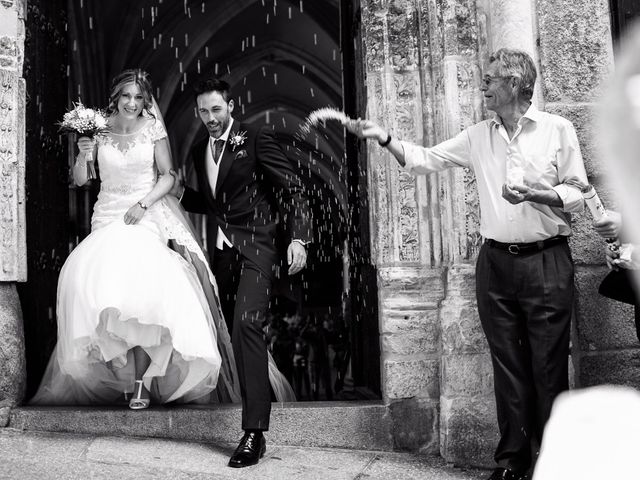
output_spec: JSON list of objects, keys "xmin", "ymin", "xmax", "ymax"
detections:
[{"xmin": 0, "ymin": 0, "xmax": 640, "ymax": 465}]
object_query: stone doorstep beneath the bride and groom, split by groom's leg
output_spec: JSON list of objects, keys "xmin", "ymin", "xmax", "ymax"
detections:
[{"xmin": 8, "ymin": 401, "xmax": 393, "ymax": 451}]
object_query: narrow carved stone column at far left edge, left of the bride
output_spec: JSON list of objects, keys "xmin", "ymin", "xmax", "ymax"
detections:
[{"xmin": 0, "ymin": 0, "xmax": 27, "ymax": 427}]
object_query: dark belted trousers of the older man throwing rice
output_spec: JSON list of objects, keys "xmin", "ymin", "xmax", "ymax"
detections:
[{"xmin": 476, "ymin": 243, "xmax": 573, "ymax": 471}]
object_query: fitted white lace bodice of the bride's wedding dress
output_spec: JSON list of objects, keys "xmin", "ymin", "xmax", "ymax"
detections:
[{"xmin": 91, "ymin": 118, "xmax": 167, "ymax": 230}]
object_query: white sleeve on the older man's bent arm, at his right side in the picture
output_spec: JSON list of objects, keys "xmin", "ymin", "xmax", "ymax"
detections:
[{"xmin": 553, "ymin": 120, "xmax": 588, "ymax": 213}]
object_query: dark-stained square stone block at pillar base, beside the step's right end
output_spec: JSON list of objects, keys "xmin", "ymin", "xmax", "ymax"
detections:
[{"xmin": 389, "ymin": 398, "xmax": 440, "ymax": 455}]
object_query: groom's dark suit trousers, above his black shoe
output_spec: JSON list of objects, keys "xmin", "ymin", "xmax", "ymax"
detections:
[{"xmin": 213, "ymin": 247, "xmax": 273, "ymax": 430}]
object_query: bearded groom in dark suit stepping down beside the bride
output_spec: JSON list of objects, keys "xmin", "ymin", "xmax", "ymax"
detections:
[{"xmin": 181, "ymin": 78, "xmax": 311, "ymax": 467}]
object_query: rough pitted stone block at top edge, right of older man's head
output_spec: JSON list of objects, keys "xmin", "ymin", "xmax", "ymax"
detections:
[{"xmin": 536, "ymin": 0, "xmax": 613, "ymax": 102}]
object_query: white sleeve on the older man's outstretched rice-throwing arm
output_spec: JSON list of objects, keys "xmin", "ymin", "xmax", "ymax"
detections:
[{"xmin": 400, "ymin": 130, "xmax": 471, "ymax": 175}]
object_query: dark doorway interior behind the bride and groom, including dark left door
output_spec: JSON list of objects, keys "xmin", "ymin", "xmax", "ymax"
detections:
[{"xmin": 21, "ymin": 0, "xmax": 380, "ymax": 400}]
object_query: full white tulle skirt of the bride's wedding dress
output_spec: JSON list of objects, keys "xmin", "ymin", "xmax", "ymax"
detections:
[{"xmin": 31, "ymin": 220, "xmax": 229, "ymax": 405}]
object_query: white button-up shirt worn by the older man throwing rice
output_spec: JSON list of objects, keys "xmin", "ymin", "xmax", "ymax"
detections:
[{"xmin": 401, "ymin": 105, "xmax": 587, "ymax": 243}]
